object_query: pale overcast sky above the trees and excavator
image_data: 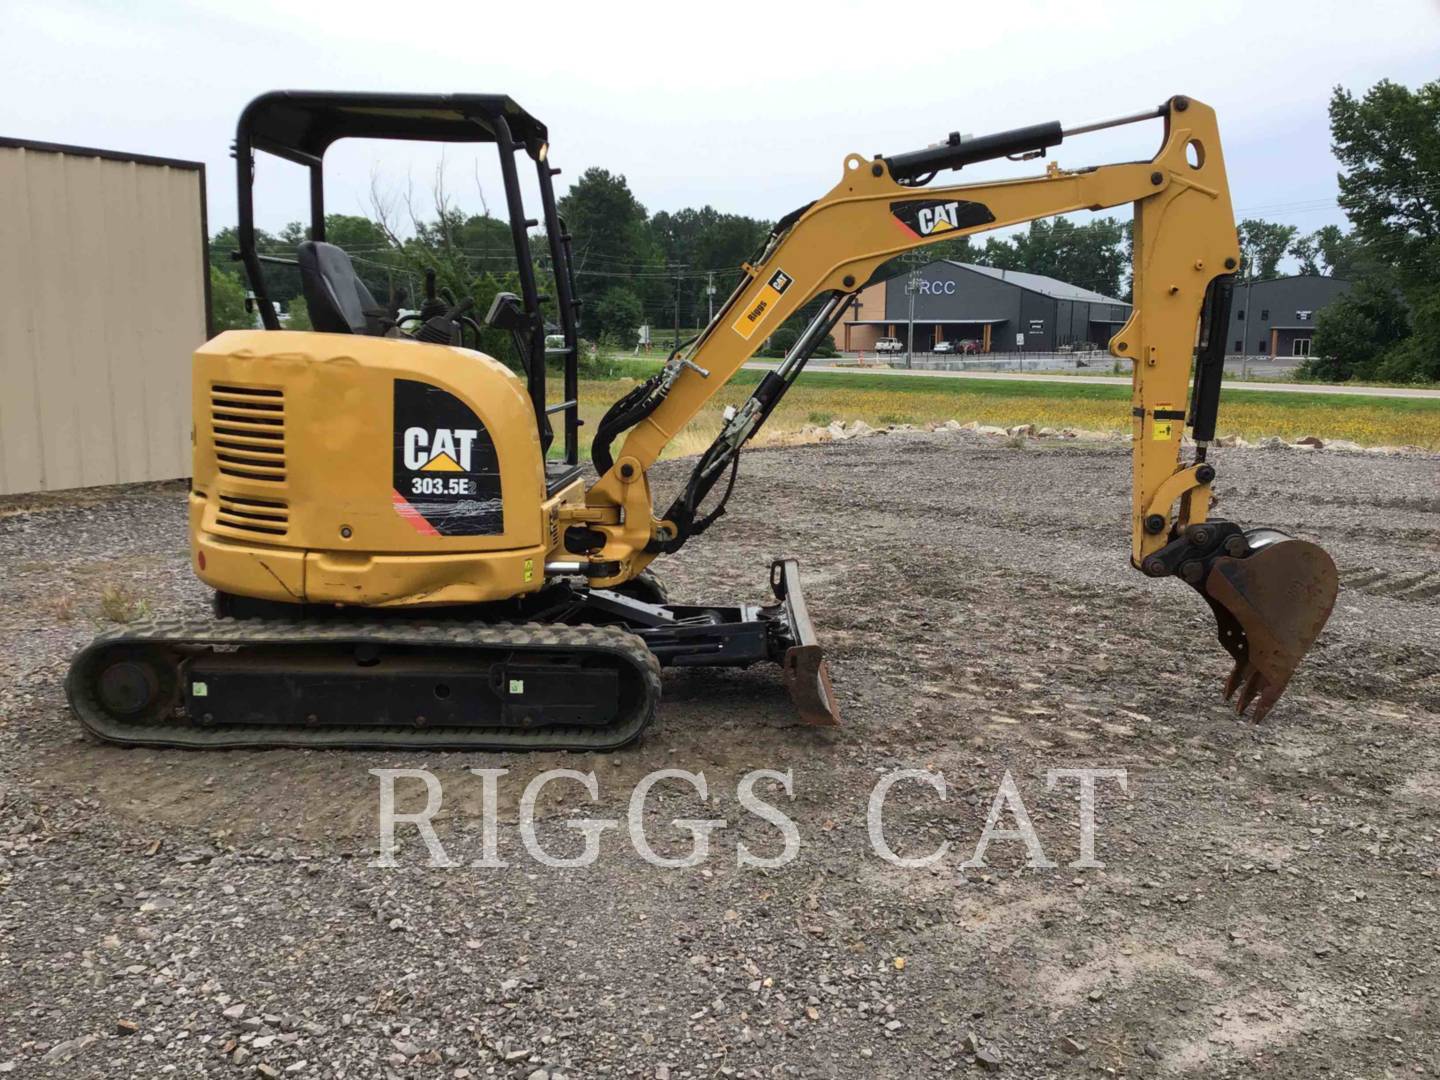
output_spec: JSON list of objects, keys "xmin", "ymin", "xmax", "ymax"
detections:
[{"xmin": 0, "ymin": 0, "xmax": 1440, "ymax": 246}]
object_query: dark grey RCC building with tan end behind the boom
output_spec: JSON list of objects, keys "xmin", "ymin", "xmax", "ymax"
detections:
[{"xmin": 834, "ymin": 259, "xmax": 1130, "ymax": 353}]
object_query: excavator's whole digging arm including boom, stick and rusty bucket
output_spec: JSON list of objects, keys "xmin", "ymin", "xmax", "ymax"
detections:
[{"xmin": 573, "ymin": 96, "xmax": 1338, "ymax": 719}]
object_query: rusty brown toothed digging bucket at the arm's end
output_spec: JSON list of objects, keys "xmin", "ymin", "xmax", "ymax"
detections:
[{"xmin": 1197, "ymin": 528, "xmax": 1339, "ymax": 723}]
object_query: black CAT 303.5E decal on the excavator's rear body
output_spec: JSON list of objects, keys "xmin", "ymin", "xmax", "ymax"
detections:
[{"xmin": 390, "ymin": 379, "xmax": 505, "ymax": 536}]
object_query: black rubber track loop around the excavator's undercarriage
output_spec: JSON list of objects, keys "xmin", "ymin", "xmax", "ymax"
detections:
[{"xmin": 65, "ymin": 619, "xmax": 660, "ymax": 750}]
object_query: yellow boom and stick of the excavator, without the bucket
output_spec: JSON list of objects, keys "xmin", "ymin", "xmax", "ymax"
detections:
[{"xmin": 586, "ymin": 98, "xmax": 1240, "ymax": 585}]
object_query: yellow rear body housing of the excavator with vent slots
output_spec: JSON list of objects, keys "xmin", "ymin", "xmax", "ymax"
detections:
[{"xmin": 190, "ymin": 330, "xmax": 585, "ymax": 608}]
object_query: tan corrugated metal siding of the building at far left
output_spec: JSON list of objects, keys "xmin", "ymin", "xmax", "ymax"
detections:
[{"xmin": 0, "ymin": 145, "xmax": 207, "ymax": 494}]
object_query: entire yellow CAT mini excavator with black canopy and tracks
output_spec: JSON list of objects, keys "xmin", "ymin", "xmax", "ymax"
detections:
[{"xmin": 66, "ymin": 91, "xmax": 1338, "ymax": 750}]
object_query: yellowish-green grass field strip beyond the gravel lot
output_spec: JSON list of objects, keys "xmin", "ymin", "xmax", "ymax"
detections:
[{"xmin": 552, "ymin": 361, "xmax": 1440, "ymax": 455}]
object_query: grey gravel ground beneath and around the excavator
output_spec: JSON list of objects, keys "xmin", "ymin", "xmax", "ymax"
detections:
[{"xmin": 0, "ymin": 432, "xmax": 1440, "ymax": 1080}]
